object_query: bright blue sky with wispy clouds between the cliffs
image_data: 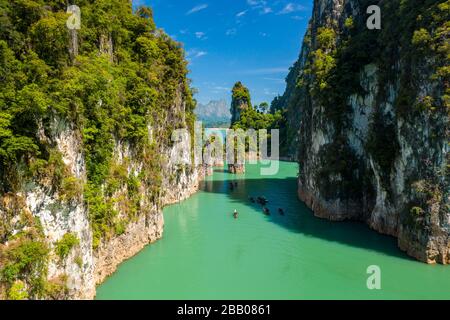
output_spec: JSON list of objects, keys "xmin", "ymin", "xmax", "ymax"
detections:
[{"xmin": 134, "ymin": 0, "xmax": 313, "ymax": 103}]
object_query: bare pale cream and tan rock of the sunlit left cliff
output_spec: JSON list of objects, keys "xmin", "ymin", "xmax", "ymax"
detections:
[{"xmin": 0, "ymin": 108, "xmax": 204, "ymax": 299}]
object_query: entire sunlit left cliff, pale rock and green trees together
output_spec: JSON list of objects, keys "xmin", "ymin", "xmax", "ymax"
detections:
[{"xmin": 0, "ymin": 0, "xmax": 199, "ymax": 299}]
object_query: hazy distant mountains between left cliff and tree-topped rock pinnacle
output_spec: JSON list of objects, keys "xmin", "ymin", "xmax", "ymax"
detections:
[{"xmin": 195, "ymin": 100, "xmax": 231, "ymax": 127}]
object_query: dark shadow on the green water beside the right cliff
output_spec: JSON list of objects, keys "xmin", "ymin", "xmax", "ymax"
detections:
[{"xmin": 200, "ymin": 175, "xmax": 412, "ymax": 260}]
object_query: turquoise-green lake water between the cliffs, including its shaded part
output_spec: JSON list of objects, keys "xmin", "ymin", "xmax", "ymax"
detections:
[{"xmin": 97, "ymin": 162, "xmax": 450, "ymax": 299}]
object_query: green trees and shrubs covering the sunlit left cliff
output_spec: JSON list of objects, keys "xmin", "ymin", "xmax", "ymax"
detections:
[{"xmin": 0, "ymin": 0, "xmax": 195, "ymax": 299}]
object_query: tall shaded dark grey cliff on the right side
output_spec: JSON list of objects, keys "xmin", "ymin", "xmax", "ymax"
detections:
[{"xmin": 280, "ymin": 0, "xmax": 450, "ymax": 264}]
